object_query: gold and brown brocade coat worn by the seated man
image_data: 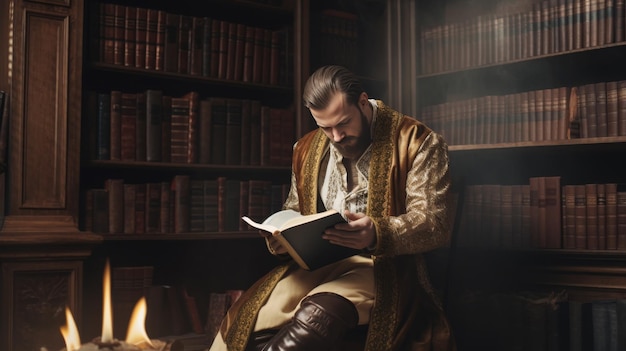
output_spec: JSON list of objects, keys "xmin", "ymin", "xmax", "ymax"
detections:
[{"xmin": 220, "ymin": 101, "xmax": 455, "ymax": 351}]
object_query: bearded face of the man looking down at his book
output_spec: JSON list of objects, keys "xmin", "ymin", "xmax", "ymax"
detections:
[{"xmin": 311, "ymin": 93, "xmax": 371, "ymax": 159}]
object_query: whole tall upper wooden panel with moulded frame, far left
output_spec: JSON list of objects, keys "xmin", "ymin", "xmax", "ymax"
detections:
[{"xmin": 3, "ymin": 1, "xmax": 82, "ymax": 231}]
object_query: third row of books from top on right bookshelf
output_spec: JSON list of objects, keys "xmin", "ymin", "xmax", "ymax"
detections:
[{"xmin": 458, "ymin": 176, "xmax": 626, "ymax": 250}]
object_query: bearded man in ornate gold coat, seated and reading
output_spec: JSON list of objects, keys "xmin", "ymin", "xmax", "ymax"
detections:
[{"xmin": 210, "ymin": 66, "xmax": 455, "ymax": 351}]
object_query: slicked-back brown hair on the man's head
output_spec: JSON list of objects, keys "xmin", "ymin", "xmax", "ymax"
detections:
[{"xmin": 302, "ymin": 65, "xmax": 364, "ymax": 110}]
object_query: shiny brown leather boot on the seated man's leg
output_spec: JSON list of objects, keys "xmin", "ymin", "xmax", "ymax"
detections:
[{"xmin": 263, "ymin": 293, "xmax": 359, "ymax": 351}]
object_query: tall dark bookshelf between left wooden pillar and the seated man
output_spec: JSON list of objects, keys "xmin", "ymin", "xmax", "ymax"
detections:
[{"xmin": 79, "ymin": 1, "xmax": 299, "ymax": 343}]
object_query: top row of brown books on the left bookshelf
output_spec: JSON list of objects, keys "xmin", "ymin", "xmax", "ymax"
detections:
[{"xmin": 98, "ymin": 3, "xmax": 293, "ymax": 86}]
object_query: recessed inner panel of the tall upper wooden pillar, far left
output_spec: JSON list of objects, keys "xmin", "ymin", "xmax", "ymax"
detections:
[{"xmin": 20, "ymin": 12, "xmax": 69, "ymax": 209}]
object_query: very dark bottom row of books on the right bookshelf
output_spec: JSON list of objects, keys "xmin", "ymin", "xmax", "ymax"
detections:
[{"xmin": 451, "ymin": 291, "xmax": 626, "ymax": 351}]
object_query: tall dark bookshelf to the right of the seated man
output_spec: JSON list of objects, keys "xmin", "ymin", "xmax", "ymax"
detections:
[{"xmin": 412, "ymin": 0, "xmax": 626, "ymax": 350}]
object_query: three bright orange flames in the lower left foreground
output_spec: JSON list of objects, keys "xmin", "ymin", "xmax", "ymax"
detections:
[{"xmin": 61, "ymin": 260, "xmax": 165, "ymax": 351}]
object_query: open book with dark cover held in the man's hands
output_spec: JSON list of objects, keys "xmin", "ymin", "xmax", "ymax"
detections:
[{"xmin": 242, "ymin": 210, "xmax": 361, "ymax": 270}]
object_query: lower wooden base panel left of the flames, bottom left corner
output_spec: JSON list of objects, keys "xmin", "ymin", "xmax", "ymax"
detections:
[{"xmin": 0, "ymin": 261, "xmax": 82, "ymax": 351}]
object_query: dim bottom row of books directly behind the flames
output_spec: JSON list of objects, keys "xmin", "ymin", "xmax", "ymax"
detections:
[{"xmin": 111, "ymin": 266, "xmax": 243, "ymax": 350}]
